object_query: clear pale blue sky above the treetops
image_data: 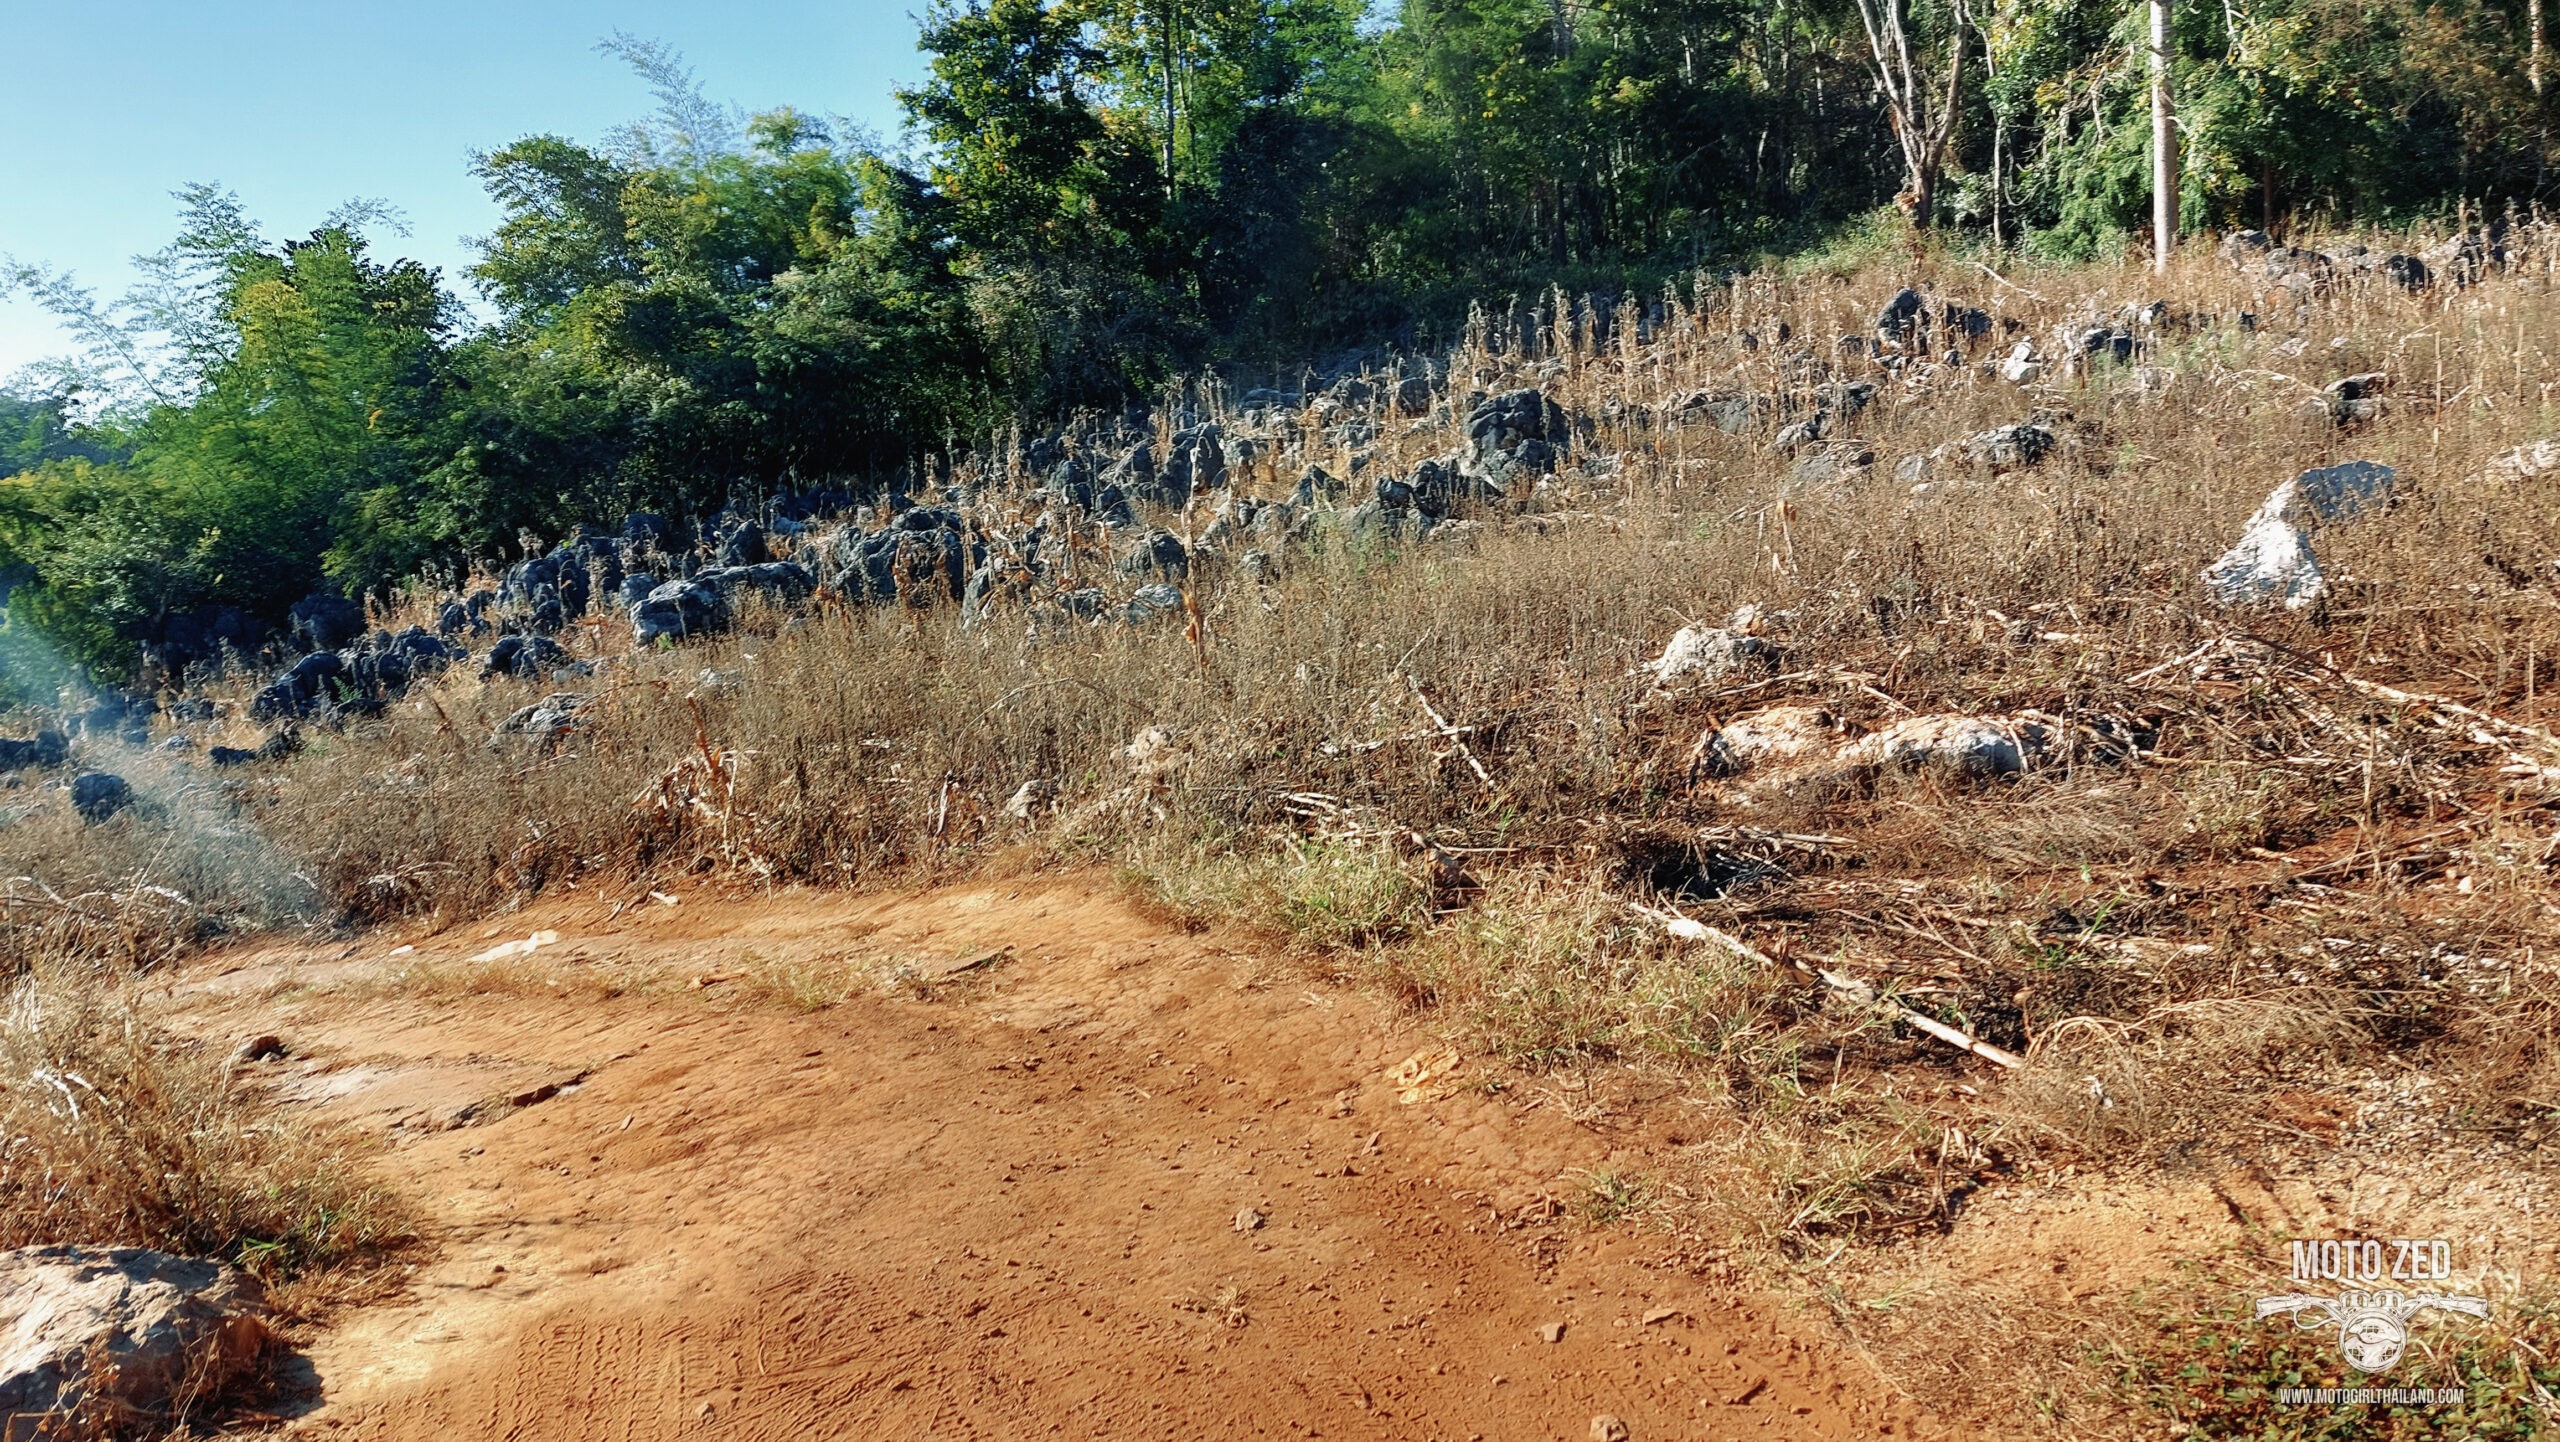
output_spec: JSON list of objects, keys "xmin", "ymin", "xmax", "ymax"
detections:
[{"xmin": 0, "ymin": 0, "xmax": 924, "ymax": 379}]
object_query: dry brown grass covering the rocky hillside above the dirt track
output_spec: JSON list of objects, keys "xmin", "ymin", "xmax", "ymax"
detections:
[{"xmin": 0, "ymin": 233, "xmax": 2560, "ymax": 1419}]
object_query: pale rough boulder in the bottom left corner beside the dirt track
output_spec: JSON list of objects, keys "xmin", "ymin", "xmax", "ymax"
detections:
[{"xmin": 0, "ymin": 1247, "xmax": 269, "ymax": 1442}]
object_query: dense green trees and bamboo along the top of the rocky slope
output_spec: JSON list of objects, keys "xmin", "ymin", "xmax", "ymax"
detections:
[{"xmin": 0, "ymin": 0, "xmax": 2552, "ymax": 668}]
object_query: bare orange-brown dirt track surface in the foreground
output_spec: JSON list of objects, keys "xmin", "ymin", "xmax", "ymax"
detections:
[{"xmin": 182, "ymin": 879, "xmax": 1938, "ymax": 1442}]
